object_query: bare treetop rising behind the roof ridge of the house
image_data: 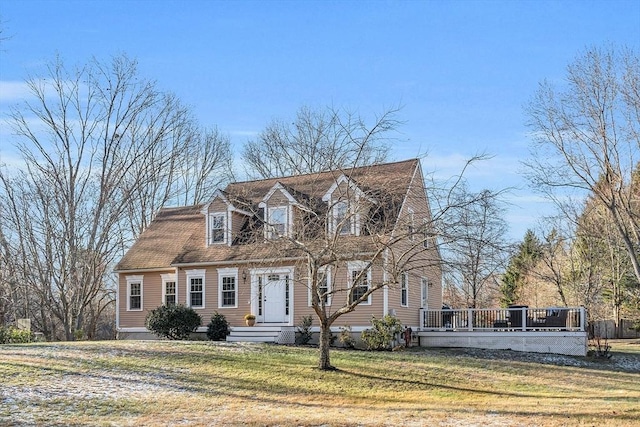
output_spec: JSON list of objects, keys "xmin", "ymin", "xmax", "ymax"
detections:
[{"xmin": 242, "ymin": 107, "xmax": 400, "ymax": 178}]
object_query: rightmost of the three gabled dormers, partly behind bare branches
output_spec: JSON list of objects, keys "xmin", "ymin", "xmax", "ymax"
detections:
[{"xmin": 322, "ymin": 174, "xmax": 377, "ymax": 236}]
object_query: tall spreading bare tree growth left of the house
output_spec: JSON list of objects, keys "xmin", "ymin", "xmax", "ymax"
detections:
[{"xmin": 0, "ymin": 56, "xmax": 234, "ymax": 340}]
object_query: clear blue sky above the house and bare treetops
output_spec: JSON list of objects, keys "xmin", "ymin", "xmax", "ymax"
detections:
[{"xmin": 0, "ymin": 0, "xmax": 640, "ymax": 239}]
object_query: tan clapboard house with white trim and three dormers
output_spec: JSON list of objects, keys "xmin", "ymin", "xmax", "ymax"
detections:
[{"xmin": 116, "ymin": 159, "xmax": 442, "ymax": 338}]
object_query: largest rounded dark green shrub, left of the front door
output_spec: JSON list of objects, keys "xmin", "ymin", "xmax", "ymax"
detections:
[{"xmin": 145, "ymin": 305, "xmax": 202, "ymax": 340}]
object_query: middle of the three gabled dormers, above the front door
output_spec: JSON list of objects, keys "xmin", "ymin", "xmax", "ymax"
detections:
[{"xmin": 258, "ymin": 182, "xmax": 304, "ymax": 239}]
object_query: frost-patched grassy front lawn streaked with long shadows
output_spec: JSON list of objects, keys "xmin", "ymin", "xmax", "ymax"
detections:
[{"xmin": 0, "ymin": 340, "xmax": 640, "ymax": 426}]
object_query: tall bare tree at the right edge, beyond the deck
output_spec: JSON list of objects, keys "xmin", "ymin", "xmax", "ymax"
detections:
[{"xmin": 526, "ymin": 47, "xmax": 640, "ymax": 280}]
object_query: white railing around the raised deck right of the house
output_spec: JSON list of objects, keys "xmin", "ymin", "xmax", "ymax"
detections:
[{"xmin": 420, "ymin": 306, "xmax": 586, "ymax": 332}]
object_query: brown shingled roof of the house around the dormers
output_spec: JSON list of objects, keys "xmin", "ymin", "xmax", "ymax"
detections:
[{"xmin": 116, "ymin": 159, "xmax": 419, "ymax": 271}]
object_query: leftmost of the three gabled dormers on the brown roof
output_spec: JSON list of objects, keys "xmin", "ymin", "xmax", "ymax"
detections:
[{"xmin": 200, "ymin": 190, "xmax": 252, "ymax": 246}]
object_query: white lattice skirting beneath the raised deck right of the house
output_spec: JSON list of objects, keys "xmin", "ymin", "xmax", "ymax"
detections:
[{"xmin": 418, "ymin": 331, "xmax": 588, "ymax": 356}]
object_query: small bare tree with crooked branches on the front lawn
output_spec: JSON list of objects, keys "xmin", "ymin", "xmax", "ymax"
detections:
[{"xmin": 235, "ymin": 139, "xmax": 490, "ymax": 369}]
